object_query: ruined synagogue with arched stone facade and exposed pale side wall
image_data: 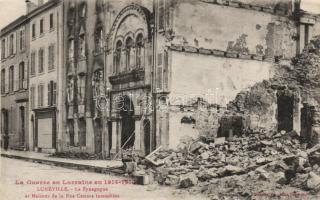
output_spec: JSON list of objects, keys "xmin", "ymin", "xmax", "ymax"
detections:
[{"xmin": 1, "ymin": 0, "xmax": 320, "ymax": 157}]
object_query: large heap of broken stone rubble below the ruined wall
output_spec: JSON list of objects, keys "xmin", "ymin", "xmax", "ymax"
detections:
[{"xmin": 129, "ymin": 130, "xmax": 320, "ymax": 196}]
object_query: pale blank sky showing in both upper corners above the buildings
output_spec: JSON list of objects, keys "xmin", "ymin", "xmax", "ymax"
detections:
[{"xmin": 0, "ymin": 0, "xmax": 320, "ymax": 29}]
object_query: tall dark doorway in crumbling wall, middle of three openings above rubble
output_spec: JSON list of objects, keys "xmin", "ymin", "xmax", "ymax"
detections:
[{"xmin": 277, "ymin": 93, "xmax": 294, "ymax": 132}]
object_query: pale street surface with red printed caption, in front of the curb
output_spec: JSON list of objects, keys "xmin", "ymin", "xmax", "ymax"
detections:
[{"xmin": 0, "ymin": 157, "xmax": 207, "ymax": 200}]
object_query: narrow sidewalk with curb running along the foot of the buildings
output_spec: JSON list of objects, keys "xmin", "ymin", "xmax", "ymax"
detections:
[{"xmin": 1, "ymin": 153, "xmax": 128, "ymax": 178}]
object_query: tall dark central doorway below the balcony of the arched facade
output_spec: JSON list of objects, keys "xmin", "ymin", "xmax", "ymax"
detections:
[{"xmin": 119, "ymin": 96, "xmax": 135, "ymax": 149}]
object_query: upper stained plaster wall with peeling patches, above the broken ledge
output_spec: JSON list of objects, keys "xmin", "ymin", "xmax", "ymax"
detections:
[{"xmin": 172, "ymin": 1, "xmax": 296, "ymax": 58}]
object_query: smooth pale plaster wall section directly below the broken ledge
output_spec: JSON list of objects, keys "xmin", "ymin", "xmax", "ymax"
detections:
[{"xmin": 170, "ymin": 52, "xmax": 272, "ymax": 106}]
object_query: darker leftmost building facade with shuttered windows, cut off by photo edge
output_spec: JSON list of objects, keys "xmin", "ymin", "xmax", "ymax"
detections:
[{"xmin": 0, "ymin": 16, "xmax": 29, "ymax": 150}]
